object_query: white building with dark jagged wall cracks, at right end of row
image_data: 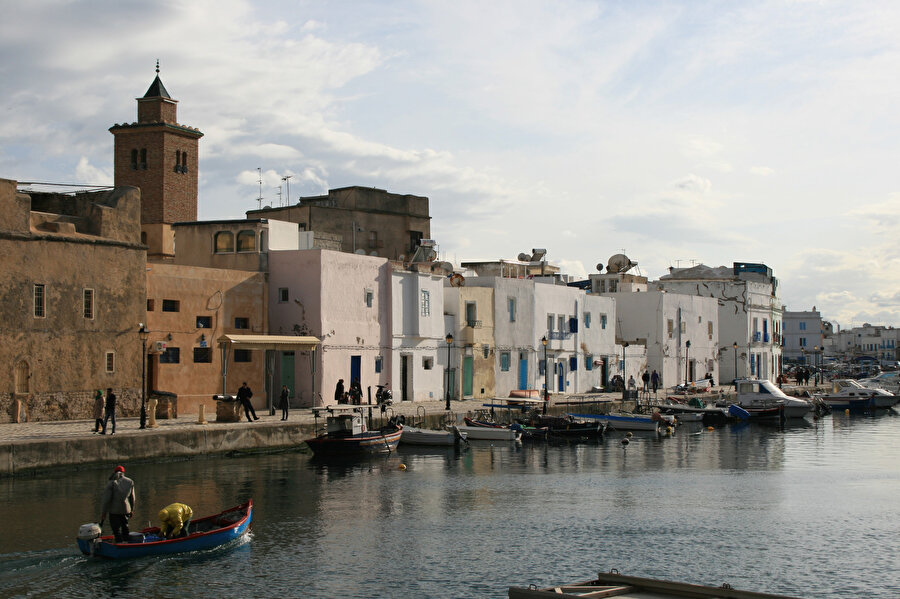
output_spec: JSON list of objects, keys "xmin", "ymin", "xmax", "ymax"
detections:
[{"xmin": 656, "ymin": 262, "xmax": 784, "ymax": 381}]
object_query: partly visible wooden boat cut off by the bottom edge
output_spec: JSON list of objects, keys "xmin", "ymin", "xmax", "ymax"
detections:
[{"xmin": 509, "ymin": 570, "xmax": 796, "ymax": 599}]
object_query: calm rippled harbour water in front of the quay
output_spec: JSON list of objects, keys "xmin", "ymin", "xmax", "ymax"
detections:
[{"xmin": 0, "ymin": 412, "xmax": 900, "ymax": 599}]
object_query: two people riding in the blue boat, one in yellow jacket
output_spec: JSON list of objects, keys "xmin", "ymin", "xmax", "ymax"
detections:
[{"xmin": 100, "ymin": 466, "xmax": 194, "ymax": 543}]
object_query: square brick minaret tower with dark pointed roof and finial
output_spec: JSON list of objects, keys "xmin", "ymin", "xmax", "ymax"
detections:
[{"xmin": 109, "ymin": 61, "xmax": 203, "ymax": 255}]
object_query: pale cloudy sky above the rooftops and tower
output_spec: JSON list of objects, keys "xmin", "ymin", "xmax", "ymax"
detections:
[{"xmin": 0, "ymin": 0, "xmax": 900, "ymax": 328}]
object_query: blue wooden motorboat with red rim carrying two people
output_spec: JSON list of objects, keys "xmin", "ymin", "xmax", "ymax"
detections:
[{"xmin": 77, "ymin": 499, "xmax": 253, "ymax": 559}]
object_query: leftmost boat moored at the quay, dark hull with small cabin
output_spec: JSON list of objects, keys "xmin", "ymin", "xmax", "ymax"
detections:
[{"xmin": 305, "ymin": 405, "xmax": 403, "ymax": 456}]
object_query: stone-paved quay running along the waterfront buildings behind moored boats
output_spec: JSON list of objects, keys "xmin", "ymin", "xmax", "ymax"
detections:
[{"xmin": 0, "ymin": 387, "xmax": 816, "ymax": 477}]
